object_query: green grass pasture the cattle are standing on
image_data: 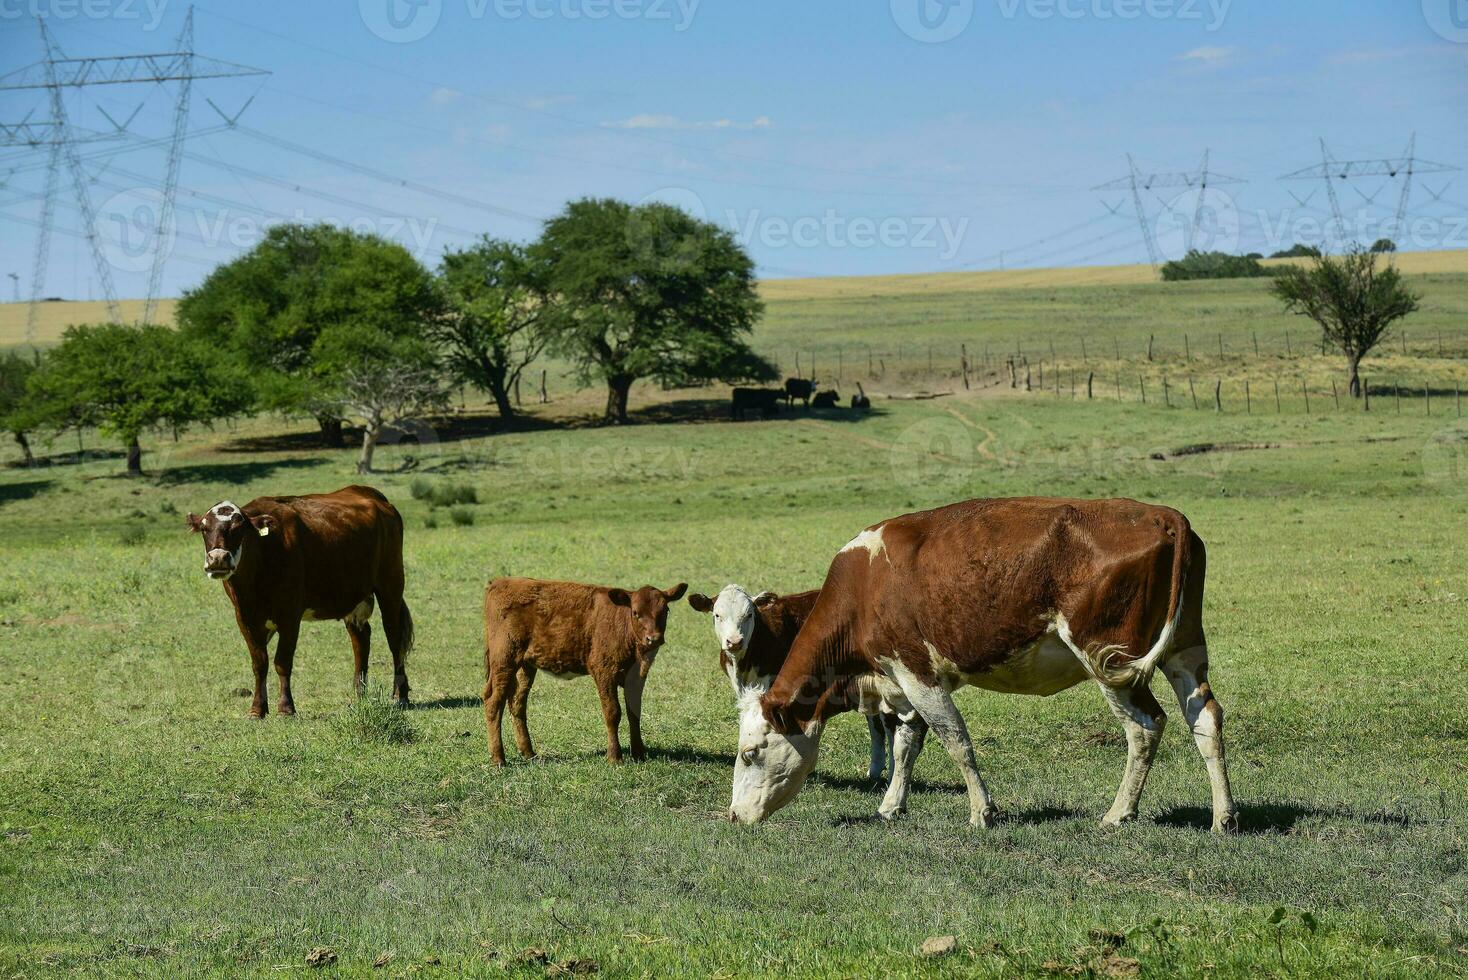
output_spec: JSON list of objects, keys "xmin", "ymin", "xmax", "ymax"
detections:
[{"xmin": 0, "ymin": 262, "xmax": 1468, "ymax": 977}]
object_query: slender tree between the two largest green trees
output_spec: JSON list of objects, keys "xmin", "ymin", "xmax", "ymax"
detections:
[{"xmin": 432, "ymin": 235, "xmax": 551, "ymax": 418}]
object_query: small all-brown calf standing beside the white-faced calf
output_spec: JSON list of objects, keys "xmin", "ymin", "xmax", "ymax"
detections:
[{"xmin": 484, "ymin": 578, "xmax": 687, "ymax": 766}]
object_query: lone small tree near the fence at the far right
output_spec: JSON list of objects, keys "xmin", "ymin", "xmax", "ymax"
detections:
[{"xmin": 1271, "ymin": 248, "xmax": 1421, "ymax": 398}]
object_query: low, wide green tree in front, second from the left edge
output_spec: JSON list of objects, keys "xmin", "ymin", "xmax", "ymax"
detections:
[{"xmin": 26, "ymin": 323, "xmax": 252, "ymax": 475}]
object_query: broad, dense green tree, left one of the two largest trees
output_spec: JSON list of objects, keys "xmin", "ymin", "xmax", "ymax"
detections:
[{"xmin": 176, "ymin": 224, "xmax": 439, "ymax": 446}]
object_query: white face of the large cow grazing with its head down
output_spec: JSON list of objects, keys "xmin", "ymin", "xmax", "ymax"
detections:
[{"xmin": 730, "ymin": 691, "xmax": 822, "ymax": 823}]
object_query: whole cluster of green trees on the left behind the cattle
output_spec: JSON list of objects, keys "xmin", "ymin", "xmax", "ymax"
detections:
[{"xmin": 0, "ymin": 200, "xmax": 777, "ymax": 474}]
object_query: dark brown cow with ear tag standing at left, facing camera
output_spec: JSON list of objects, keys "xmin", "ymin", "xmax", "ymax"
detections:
[{"xmin": 188, "ymin": 486, "xmax": 413, "ymax": 717}]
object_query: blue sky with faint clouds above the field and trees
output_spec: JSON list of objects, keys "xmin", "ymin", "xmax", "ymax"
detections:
[{"xmin": 0, "ymin": 0, "xmax": 1468, "ymax": 299}]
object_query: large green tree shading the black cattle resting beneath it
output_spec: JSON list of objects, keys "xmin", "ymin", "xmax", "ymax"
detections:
[{"xmin": 530, "ymin": 200, "xmax": 777, "ymax": 423}]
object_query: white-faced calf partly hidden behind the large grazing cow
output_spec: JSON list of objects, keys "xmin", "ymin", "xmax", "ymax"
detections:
[{"xmin": 688, "ymin": 585, "xmax": 926, "ymax": 817}]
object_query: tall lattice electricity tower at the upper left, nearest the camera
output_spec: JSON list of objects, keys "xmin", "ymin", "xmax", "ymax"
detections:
[{"xmin": 0, "ymin": 7, "xmax": 269, "ymax": 342}]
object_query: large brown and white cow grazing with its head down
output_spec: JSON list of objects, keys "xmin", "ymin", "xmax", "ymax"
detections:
[{"xmin": 730, "ymin": 497, "xmax": 1238, "ymax": 830}]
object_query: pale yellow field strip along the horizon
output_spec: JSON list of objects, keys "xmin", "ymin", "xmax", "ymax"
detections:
[{"xmin": 0, "ymin": 249, "xmax": 1468, "ymax": 348}]
